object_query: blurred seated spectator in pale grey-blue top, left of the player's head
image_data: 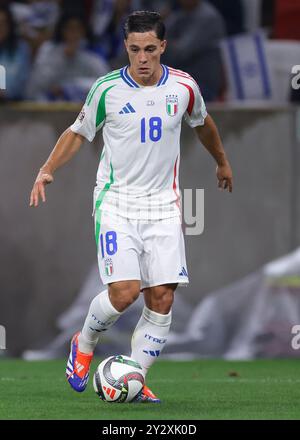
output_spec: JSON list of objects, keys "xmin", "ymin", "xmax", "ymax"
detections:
[{"xmin": 27, "ymin": 15, "xmax": 109, "ymax": 101}]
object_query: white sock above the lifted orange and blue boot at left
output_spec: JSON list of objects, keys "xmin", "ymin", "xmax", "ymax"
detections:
[{"xmin": 78, "ymin": 290, "xmax": 122, "ymax": 354}]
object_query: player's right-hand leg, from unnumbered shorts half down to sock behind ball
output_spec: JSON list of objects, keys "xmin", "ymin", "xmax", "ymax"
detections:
[{"xmin": 131, "ymin": 221, "xmax": 188, "ymax": 400}]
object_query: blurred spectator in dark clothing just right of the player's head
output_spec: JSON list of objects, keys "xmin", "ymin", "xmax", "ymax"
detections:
[{"xmin": 164, "ymin": 0, "xmax": 225, "ymax": 101}]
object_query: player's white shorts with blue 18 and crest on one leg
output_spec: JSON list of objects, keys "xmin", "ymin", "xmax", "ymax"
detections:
[{"xmin": 95, "ymin": 211, "xmax": 189, "ymax": 290}]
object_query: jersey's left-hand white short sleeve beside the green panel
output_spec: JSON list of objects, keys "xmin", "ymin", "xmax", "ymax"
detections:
[{"xmin": 70, "ymin": 80, "xmax": 104, "ymax": 142}]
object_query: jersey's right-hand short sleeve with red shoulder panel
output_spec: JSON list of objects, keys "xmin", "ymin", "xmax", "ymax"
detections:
[{"xmin": 184, "ymin": 80, "xmax": 207, "ymax": 128}]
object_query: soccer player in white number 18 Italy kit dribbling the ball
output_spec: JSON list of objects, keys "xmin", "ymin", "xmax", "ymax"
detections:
[{"xmin": 30, "ymin": 11, "xmax": 232, "ymax": 402}]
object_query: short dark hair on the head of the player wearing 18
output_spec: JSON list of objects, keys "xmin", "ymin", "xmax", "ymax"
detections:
[{"xmin": 123, "ymin": 11, "xmax": 166, "ymax": 40}]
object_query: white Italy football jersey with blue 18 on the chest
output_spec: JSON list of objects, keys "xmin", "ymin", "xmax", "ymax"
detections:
[{"xmin": 71, "ymin": 65, "xmax": 207, "ymax": 220}]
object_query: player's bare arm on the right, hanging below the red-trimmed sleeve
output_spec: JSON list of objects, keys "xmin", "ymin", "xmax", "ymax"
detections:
[{"xmin": 194, "ymin": 115, "xmax": 233, "ymax": 192}]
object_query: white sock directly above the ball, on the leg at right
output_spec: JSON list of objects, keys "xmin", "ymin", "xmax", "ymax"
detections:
[{"xmin": 131, "ymin": 306, "xmax": 172, "ymax": 376}]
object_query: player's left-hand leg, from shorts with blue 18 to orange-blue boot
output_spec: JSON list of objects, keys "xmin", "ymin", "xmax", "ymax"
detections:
[{"xmin": 66, "ymin": 210, "xmax": 140, "ymax": 391}]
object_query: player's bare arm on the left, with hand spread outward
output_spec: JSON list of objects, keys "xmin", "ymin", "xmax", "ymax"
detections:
[{"xmin": 30, "ymin": 128, "xmax": 85, "ymax": 207}]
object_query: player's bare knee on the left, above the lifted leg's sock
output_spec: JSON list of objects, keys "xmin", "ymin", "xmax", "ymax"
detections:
[{"xmin": 109, "ymin": 281, "xmax": 140, "ymax": 312}]
